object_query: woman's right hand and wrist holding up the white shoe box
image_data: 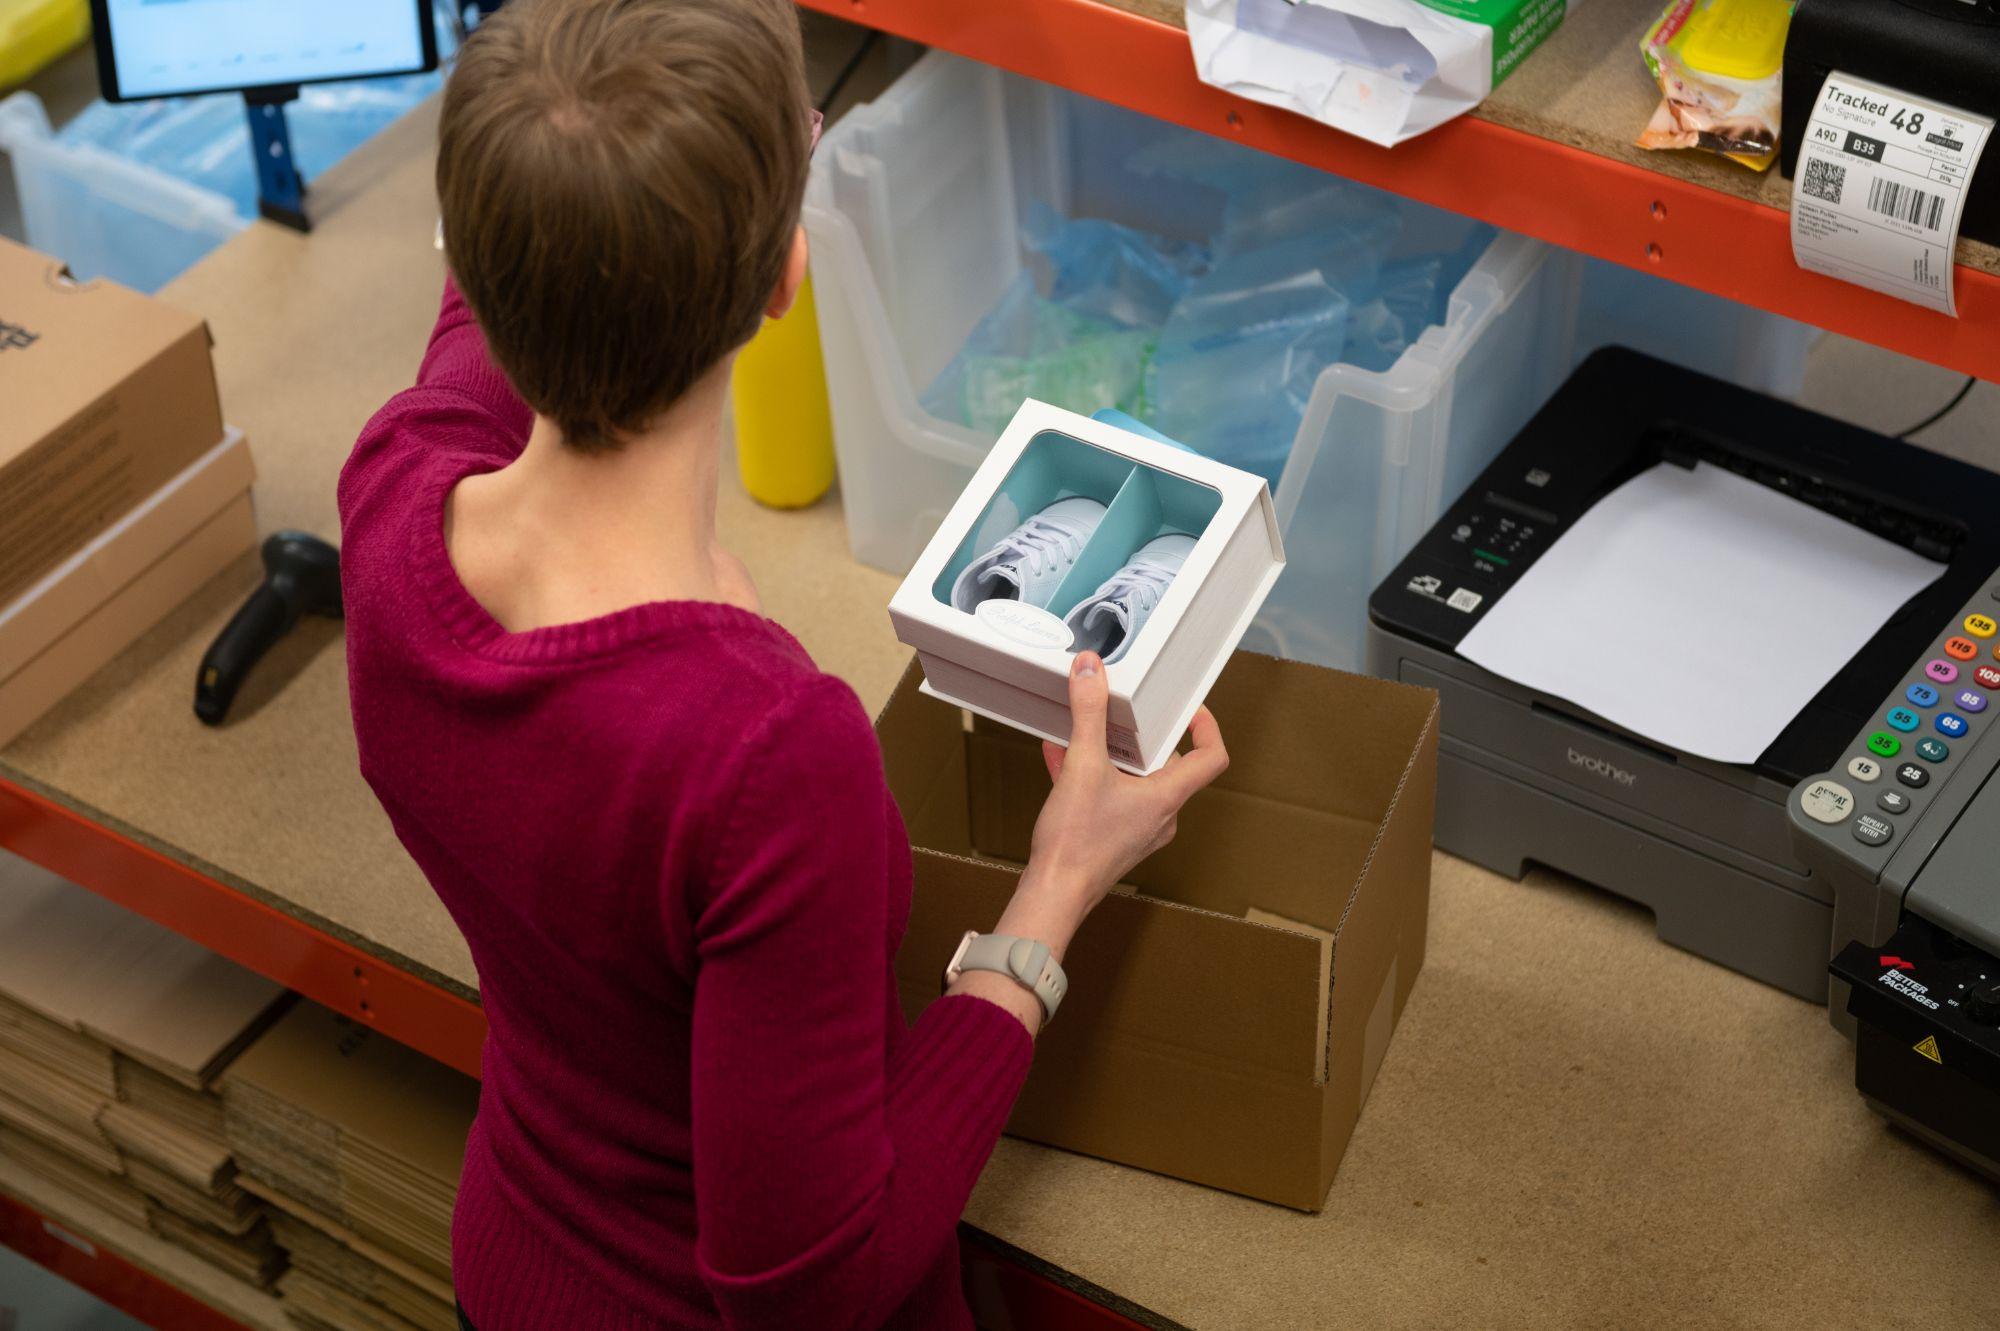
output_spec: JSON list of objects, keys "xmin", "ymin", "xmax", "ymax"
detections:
[{"xmin": 952, "ymin": 652, "xmax": 1230, "ymax": 1033}]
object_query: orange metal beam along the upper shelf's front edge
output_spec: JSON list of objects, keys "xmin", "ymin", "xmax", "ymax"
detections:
[{"xmin": 798, "ymin": 0, "xmax": 2000, "ymax": 380}]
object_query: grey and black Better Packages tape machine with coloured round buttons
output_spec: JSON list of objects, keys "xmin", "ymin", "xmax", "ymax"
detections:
[{"xmin": 1790, "ymin": 591, "xmax": 2000, "ymax": 1179}]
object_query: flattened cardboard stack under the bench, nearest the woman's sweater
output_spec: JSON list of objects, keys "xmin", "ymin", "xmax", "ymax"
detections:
[{"xmin": 222, "ymin": 1003, "xmax": 478, "ymax": 1331}]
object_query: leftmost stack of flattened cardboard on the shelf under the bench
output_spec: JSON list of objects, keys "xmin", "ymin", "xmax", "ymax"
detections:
[{"xmin": 0, "ymin": 855, "xmax": 288, "ymax": 1285}]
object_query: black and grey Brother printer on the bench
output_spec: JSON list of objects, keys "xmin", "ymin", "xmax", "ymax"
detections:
[{"xmin": 1368, "ymin": 348, "xmax": 2000, "ymax": 1001}]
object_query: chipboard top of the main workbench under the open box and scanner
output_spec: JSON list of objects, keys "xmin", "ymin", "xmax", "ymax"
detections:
[{"xmin": 0, "ymin": 87, "xmax": 2000, "ymax": 1329}]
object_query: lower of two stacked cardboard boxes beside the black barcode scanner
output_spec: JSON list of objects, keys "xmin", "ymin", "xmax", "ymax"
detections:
[{"xmin": 0, "ymin": 430, "xmax": 256, "ymax": 743}]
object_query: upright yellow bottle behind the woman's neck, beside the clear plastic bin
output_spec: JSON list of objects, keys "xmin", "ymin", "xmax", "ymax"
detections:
[{"xmin": 734, "ymin": 276, "xmax": 834, "ymax": 508}]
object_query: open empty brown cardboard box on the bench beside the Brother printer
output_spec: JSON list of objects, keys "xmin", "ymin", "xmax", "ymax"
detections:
[{"xmin": 876, "ymin": 652, "xmax": 1438, "ymax": 1211}]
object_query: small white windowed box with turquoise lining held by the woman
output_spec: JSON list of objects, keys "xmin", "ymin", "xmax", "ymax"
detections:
[{"xmin": 888, "ymin": 400, "xmax": 1284, "ymax": 773}]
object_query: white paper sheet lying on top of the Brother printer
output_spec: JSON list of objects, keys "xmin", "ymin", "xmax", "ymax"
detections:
[{"xmin": 1458, "ymin": 462, "xmax": 1944, "ymax": 763}]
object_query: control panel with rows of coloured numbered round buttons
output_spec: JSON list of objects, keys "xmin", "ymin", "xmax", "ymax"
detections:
[{"xmin": 1792, "ymin": 574, "xmax": 2000, "ymax": 873}]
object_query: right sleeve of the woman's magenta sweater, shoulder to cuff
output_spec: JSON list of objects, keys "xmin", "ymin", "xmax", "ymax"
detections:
[{"xmin": 692, "ymin": 679, "xmax": 1032, "ymax": 1331}]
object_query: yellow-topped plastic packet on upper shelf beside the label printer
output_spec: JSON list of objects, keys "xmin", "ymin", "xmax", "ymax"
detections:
[{"xmin": 1638, "ymin": 0, "xmax": 1792, "ymax": 170}]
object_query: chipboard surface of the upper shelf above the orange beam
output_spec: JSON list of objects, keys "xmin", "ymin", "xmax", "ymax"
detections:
[{"xmin": 1102, "ymin": 0, "xmax": 2000, "ymax": 272}]
